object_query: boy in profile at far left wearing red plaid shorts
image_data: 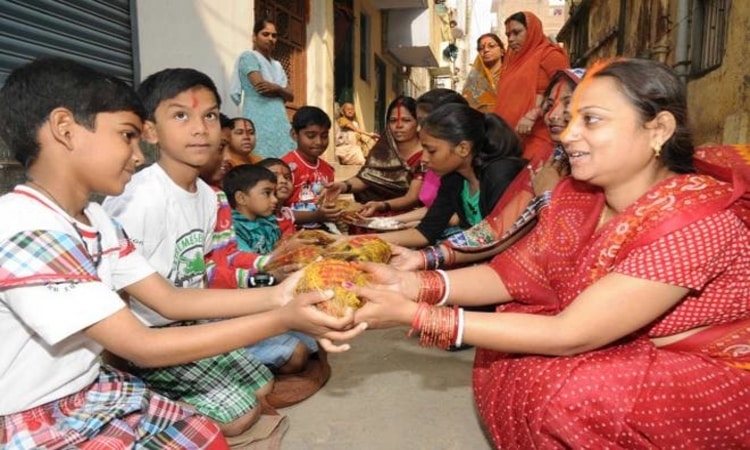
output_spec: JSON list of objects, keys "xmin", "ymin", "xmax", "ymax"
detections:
[{"xmin": 0, "ymin": 58, "xmax": 362, "ymax": 449}]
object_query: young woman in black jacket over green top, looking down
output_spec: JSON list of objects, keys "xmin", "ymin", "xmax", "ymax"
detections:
[{"xmin": 379, "ymin": 104, "xmax": 526, "ymax": 247}]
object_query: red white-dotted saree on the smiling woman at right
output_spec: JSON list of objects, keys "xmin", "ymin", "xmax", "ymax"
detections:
[{"xmin": 473, "ymin": 175, "xmax": 750, "ymax": 448}]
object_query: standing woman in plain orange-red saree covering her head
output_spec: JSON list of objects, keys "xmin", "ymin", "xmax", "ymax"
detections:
[{"xmin": 495, "ymin": 11, "xmax": 570, "ymax": 167}]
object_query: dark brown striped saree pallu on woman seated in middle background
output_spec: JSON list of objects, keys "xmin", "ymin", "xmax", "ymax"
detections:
[{"xmin": 354, "ymin": 132, "xmax": 422, "ymax": 203}]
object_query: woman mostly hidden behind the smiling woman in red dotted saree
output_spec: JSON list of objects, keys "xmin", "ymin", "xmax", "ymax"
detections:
[{"xmin": 391, "ymin": 69, "xmax": 585, "ymax": 270}]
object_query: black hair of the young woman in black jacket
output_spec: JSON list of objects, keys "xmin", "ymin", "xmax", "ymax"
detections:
[{"xmin": 422, "ymin": 103, "xmax": 522, "ymax": 175}]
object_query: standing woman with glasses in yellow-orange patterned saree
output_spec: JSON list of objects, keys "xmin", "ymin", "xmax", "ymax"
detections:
[{"xmin": 462, "ymin": 33, "xmax": 505, "ymax": 113}]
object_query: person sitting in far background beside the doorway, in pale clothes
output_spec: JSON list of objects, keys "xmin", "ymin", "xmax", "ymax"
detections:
[{"xmin": 334, "ymin": 102, "xmax": 380, "ymax": 165}]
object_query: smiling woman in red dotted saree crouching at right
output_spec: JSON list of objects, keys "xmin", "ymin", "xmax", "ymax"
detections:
[{"xmin": 352, "ymin": 59, "xmax": 750, "ymax": 448}]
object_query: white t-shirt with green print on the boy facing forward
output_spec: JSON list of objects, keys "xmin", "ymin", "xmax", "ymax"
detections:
[{"xmin": 103, "ymin": 164, "xmax": 218, "ymax": 326}]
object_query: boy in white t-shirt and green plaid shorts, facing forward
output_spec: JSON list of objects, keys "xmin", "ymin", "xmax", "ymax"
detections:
[{"xmin": 103, "ymin": 69, "xmax": 356, "ymax": 434}]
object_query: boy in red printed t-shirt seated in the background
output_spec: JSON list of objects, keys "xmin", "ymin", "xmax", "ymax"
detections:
[{"xmin": 281, "ymin": 106, "xmax": 342, "ymax": 228}]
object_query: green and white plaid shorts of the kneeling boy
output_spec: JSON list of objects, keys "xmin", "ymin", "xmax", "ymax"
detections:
[{"xmin": 130, "ymin": 349, "xmax": 273, "ymax": 423}]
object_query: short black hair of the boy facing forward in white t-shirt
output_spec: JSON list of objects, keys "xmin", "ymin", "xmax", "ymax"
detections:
[{"xmin": 138, "ymin": 68, "xmax": 221, "ymax": 121}]
